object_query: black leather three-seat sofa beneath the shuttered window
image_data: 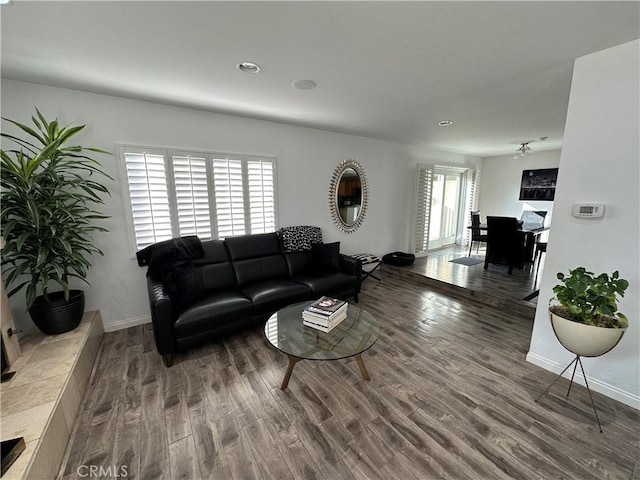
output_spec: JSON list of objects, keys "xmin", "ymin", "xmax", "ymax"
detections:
[{"xmin": 138, "ymin": 233, "xmax": 362, "ymax": 367}]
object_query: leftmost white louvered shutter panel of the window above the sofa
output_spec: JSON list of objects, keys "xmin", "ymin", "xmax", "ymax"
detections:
[{"xmin": 125, "ymin": 152, "xmax": 172, "ymax": 250}]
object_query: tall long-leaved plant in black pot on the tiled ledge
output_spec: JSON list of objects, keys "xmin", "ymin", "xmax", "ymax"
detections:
[{"xmin": 0, "ymin": 109, "xmax": 111, "ymax": 335}]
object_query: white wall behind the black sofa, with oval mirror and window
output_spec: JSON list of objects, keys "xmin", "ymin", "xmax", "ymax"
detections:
[{"xmin": 2, "ymin": 80, "xmax": 478, "ymax": 330}]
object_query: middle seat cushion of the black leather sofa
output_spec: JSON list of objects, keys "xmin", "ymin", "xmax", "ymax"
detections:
[{"xmin": 240, "ymin": 280, "xmax": 312, "ymax": 316}]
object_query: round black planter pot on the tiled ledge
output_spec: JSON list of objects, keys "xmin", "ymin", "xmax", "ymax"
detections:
[{"xmin": 29, "ymin": 290, "xmax": 84, "ymax": 335}]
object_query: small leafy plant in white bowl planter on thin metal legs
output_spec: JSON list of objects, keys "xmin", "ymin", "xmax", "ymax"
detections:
[{"xmin": 549, "ymin": 267, "xmax": 629, "ymax": 357}]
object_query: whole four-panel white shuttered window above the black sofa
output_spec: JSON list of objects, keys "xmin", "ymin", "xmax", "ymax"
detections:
[{"xmin": 120, "ymin": 146, "xmax": 277, "ymax": 251}]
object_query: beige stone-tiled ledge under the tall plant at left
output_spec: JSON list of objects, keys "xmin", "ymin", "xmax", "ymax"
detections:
[{"xmin": 0, "ymin": 311, "xmax": 104, "ymax": 480}]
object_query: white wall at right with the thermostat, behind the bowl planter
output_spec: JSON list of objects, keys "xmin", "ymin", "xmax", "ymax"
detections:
[{"xmin": 527, "ymin": 40, "xmax": 640, "ymax": 409}]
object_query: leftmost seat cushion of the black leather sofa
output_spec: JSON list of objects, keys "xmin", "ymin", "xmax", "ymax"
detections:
[{"xmin": 173, "ymin": 290, "xmax": 253, "ymax": 338}]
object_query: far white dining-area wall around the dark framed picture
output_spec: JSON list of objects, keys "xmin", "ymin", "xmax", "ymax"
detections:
[{"xmin": 478, "ymin": 149, "xmax": 560, "ymax": 224}]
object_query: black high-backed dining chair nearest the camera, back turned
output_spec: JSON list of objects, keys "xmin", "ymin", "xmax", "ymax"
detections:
[{"xmin": 484, "ymin": 217, "xmax": 525, "ymax": 275}]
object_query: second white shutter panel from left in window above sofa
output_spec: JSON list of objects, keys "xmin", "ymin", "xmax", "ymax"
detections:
[{"xmin": 172, "ymin": 154, "xmax": 212, "ymax": 240}]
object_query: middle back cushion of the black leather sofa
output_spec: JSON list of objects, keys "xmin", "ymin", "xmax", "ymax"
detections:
[{"xmin": 225, "ymin": 233, "xmax": 289, "ymax": 287}]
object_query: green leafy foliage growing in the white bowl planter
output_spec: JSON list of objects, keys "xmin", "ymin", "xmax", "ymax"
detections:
[{"xmin": 551, "ymin": 267, "xmax": 629, "ymax": 328}]
